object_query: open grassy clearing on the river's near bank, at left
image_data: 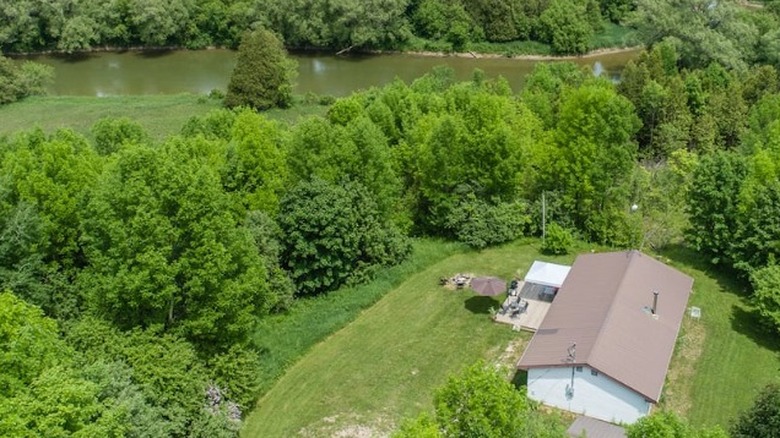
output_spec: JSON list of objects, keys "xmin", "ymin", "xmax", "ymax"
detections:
[{"xmin": 0, "ymin": 94, "xmax": 327, "ymax": 140}]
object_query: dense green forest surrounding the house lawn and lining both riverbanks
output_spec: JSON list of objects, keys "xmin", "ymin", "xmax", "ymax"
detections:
[{"xmin": 0, "ymin": 0, "xmax": 780, "ymax": 437}]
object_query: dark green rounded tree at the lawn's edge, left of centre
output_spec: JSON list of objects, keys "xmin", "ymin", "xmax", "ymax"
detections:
[{"xmin": 279, "ymin": 177, "xmax": 410, "ymax": 294}]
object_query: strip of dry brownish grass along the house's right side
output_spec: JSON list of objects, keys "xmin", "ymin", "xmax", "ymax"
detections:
[{"xmin": 660, "ymin": 317, "xmax": 707, "ymax": 416}]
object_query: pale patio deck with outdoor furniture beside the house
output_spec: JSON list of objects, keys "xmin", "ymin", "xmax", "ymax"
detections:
[{"xmin": 493, "ymin": 281, "xmax": 554, "ymax": 332}]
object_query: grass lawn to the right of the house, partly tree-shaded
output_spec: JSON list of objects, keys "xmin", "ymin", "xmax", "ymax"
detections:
[{"xmin": 663, "ymin": 248, "xmax": 780, "ymax": 428}]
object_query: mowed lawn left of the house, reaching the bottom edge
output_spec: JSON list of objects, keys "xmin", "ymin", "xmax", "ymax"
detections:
[{"xmin": 242, "ymin": 240, "xmax": 574, "ymax": 438}]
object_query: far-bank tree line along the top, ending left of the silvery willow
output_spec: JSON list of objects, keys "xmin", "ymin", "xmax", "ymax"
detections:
[{"xmin": 0, "ymin": 0, "xmax": 634, "ymax": 53}]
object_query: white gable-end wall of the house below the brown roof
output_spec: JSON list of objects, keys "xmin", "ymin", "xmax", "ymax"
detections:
[{"xmin": 528, "ymin": 366, "xmax": 652, "ymax": 424}]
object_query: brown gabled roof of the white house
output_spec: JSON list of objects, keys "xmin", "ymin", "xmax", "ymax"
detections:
[{"xmin": 517, "ymin": 250, "xmax": 693, "ymax": 403}]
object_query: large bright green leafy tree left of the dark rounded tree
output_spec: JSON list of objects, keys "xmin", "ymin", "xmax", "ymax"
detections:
[{"xmin": 81, "ymin": 142, "xmax": 272, "ymax": 347}]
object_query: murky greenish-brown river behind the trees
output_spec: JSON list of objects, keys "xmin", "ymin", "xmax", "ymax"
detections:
[{"xmin": 21, "ymin": 49, "xmax": 638, "ymax": 96}]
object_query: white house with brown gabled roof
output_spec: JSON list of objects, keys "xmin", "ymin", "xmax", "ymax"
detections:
[{"xmin": 518, "ymin": 250, "xmax": 693, "ymax": 423}]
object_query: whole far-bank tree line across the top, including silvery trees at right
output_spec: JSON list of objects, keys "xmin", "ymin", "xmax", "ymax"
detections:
[{"xmin": 0, "ymin": 0, "xmax": 780, "ymax": 56}]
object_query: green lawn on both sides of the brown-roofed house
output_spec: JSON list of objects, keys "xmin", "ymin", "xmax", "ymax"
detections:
[{"xmin": 242, "ymin": 240, "xmax": 780, "ymax": 437}]
